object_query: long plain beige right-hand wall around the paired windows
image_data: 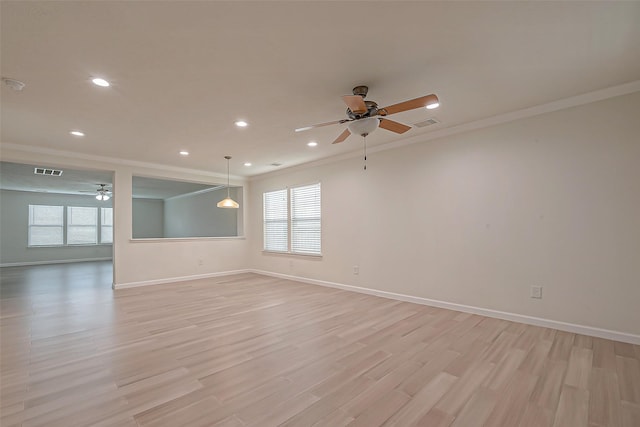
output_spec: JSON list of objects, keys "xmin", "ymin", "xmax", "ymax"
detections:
[{"xmin": 248, "ymin": 93, "xmax": 640, "ymax": 335}]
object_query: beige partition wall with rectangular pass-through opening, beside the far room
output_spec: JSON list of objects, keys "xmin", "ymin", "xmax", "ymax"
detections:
[{"xmin": 0, "ymin": 148, "xmax": 249, "ymax": 288}]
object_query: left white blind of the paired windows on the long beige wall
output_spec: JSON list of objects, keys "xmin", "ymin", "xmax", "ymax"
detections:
[{"xmin": 263, "ymin": 190, "xmax": 289, "ymax": 252}]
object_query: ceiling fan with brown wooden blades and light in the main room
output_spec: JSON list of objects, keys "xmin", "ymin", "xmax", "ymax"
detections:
[{"xmin": 295, "ymin": 86, "xmax": 440, "ymax": 144}]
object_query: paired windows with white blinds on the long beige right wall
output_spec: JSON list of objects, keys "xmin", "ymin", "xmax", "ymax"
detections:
[{"xmin": 263, "ymin": 183, "xmax": 321, "ymax": 255}]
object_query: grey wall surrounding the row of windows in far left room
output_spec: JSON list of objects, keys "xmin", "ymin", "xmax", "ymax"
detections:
[{"xmin": 0, "ymin": 190, "xmax": 112, "ymax": 265}]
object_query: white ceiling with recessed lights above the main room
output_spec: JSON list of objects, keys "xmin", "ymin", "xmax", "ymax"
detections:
[{"xmin": 0, "ymin": 1, "xmax": 640, "ymax": 176}]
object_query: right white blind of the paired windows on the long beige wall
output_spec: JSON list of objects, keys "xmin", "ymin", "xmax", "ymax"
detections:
[{"xmin": 291, "ymin": 183, "xmax": 321, "ymax": 255}]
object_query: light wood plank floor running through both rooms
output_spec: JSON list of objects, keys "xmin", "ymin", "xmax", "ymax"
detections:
[{"xmin": 0, "ymin": 263, "xmax": 640, "ymax": 427}]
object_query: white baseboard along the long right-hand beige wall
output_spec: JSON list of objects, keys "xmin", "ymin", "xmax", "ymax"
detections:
[{"xmin": 248, "ymin": 269, "xmax": 640, "ymax": 345}]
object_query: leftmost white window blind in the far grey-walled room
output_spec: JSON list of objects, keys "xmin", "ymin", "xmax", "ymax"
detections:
[{"xmin": 28, "ymin": 205, "xmax": 64, "ymax": 246}]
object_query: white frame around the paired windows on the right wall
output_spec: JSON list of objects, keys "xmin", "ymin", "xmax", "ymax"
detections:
[{"xmin": 262, "ymin": 182, "xmax": 322, "ymax": 257}]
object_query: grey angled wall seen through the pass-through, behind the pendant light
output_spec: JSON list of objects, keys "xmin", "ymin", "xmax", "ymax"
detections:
[{"xmin": 164, "ymin": 188, "xmax": 240, "ymax": 237}]
